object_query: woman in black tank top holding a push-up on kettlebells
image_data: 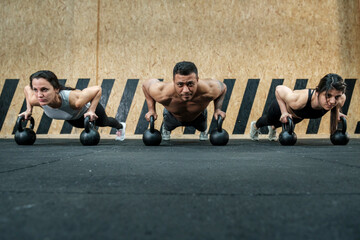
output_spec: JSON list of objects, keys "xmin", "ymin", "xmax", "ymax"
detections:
[{"xmin": 250, "ymin": 73, "xmax": 346, "ymax": 141}]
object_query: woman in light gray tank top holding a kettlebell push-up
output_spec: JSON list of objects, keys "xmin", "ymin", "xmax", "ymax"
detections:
[{"xmin": 19, "ymin": 70, "xmax": 126, "ymax": 141}]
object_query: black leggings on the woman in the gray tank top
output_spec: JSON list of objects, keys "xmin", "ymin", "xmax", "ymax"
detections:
[{"xmin": 66, "ymin": 103, "xmax": 123, "ymax": 129}]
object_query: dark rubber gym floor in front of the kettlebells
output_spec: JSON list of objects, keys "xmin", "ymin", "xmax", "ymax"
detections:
[{"xmin": 0, "ymin": 139, "xmax": 360, "ymax": 240}]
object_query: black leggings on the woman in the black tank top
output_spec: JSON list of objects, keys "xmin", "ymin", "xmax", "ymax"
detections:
[{"xmin": 255, "ymin": 100, "xmax": 303, "ymax": 128}]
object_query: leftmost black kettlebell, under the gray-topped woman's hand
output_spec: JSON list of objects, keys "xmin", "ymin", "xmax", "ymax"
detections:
[{"xmin": 15, "ymin": 116, "xmax": 36, "ymax": 145}]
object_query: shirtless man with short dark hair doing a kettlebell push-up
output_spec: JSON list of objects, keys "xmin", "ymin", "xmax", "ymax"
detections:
[{"xmin": 142, "ymin": 62, "xmax": 226, "ymax": 140}]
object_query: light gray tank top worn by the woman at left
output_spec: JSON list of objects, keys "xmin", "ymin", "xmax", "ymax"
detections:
[{"xmin": 43, "ymin": 90, "xmax": 90, "ymax": 120}]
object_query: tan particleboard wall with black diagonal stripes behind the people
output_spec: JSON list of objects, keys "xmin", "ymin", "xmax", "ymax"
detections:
[{"xmin": 0, "ymin": 0, "xmax": 360, "ymax": 138}]
